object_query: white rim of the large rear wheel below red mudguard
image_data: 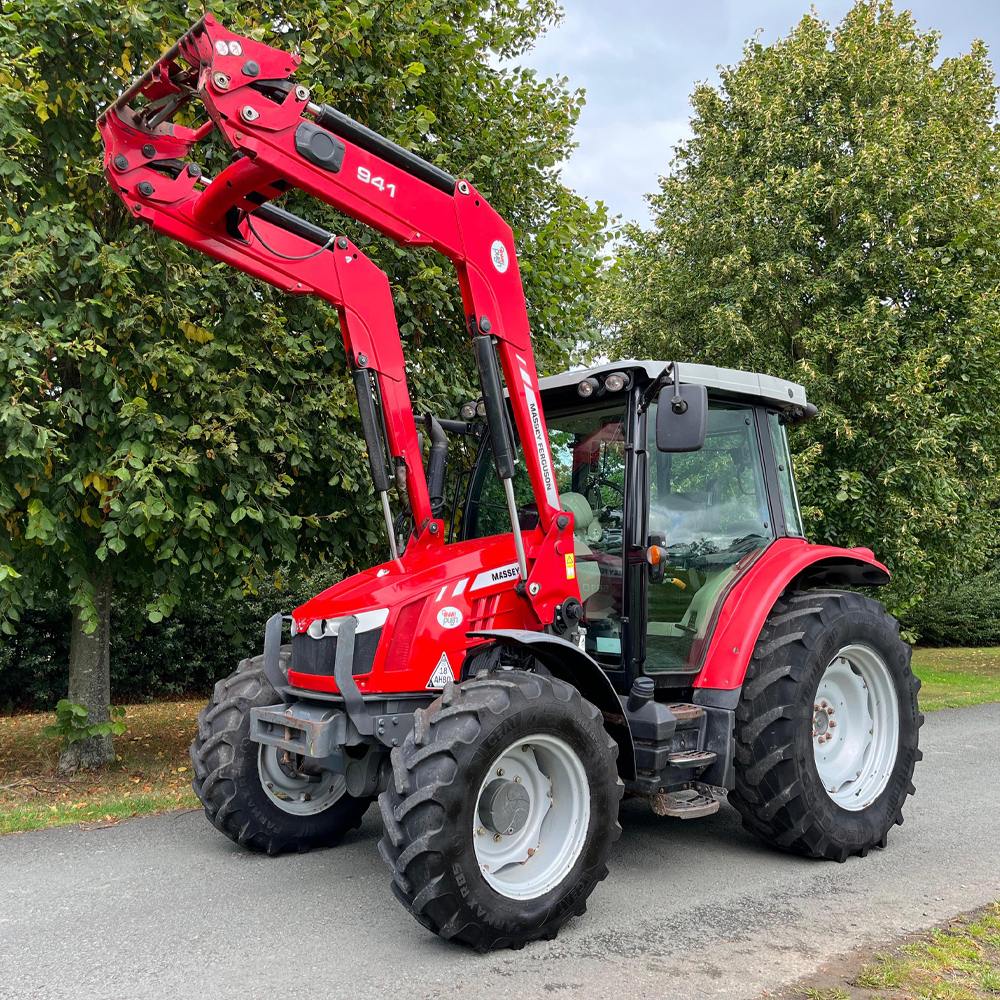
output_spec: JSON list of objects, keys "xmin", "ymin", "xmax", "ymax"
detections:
[{"xmin": 812, "ymin": 645, "xmax": 899, "ymax": 812}]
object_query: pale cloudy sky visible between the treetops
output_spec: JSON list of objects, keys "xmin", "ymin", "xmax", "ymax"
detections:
[{"xmin": 520, "ymin": 0, "xmax": 1000, "ymax": 224}]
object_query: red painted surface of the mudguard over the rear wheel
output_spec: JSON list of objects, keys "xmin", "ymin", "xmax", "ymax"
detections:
[{"xmin": 694, "ymin": 538, "xmax": 889, "ymax": 690}]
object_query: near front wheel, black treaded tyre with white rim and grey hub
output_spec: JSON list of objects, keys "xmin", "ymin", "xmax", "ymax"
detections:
[{"xmin": 379, "ymin": 670, "xmax": 624, "ymax": 951}]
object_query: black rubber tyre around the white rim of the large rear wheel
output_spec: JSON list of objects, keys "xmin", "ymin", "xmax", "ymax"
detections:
[{"xmin": 729, "ymin": 590, "xmax": 923, "ymax": 861}]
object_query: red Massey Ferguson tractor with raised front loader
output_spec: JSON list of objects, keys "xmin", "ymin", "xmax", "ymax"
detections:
[{"xmin": 99, "ymin": 16, "xmax": 922, "ymax": 951}]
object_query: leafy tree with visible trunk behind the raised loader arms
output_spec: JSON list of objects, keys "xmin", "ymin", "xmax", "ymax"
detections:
[{"xmin": 0, "ymin": 0, "xmax": 605, "ymax": 767}]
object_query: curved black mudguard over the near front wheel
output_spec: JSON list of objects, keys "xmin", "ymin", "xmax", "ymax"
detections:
[{"xmin": 462, "ymin": 629, "xmax": 635, "ymax": 779}]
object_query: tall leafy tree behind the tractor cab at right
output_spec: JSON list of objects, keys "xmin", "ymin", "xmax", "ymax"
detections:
[{"xmin": 602, "ymin": 0, "xmax": 1000, "ymax": 612}]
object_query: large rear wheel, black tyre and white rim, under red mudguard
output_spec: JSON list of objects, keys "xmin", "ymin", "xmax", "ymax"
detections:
[{"xmin": 729, "ymin": 591, "xmax": 923, "ymax": 861}]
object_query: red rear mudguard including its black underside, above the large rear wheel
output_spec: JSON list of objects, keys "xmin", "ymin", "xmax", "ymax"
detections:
[{"xmin": 694, "ymin": 538, "xmax": 889, "ymax": 691}]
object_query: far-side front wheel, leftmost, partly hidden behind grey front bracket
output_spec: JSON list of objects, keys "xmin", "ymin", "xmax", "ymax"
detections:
[{"xmin": 191, "ymin": 651, "xmax": 372, "ymax": 854}]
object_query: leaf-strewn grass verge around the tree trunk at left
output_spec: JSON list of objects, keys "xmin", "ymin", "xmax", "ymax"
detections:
[{"xmin": 0, "ymin": 701, "xmax": 203, "ymax": 834}]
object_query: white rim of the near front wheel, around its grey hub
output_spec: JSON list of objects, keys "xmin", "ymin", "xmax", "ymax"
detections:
[{"xmin": 472, "ymin": 733, "xmax": 590, "ymax": 899}]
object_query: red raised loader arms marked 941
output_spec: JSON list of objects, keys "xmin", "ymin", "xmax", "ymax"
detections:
[{"xmin": 98, "ymin": 15, "xmax": 578, "ymax": 588}]
